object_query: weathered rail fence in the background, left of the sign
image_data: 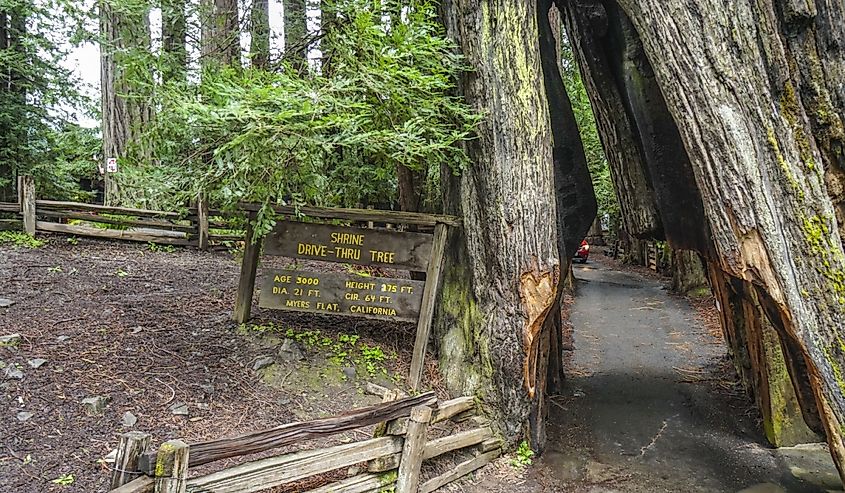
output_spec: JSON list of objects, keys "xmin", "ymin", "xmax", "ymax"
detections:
[{"xmin": 0, "ymin": 176, "xmax": 246, "ymax": 249}]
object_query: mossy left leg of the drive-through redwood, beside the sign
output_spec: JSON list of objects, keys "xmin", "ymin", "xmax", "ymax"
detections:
[{"xmin": 435, "ymin": 0, "xmax": 595, "ymax": 443}]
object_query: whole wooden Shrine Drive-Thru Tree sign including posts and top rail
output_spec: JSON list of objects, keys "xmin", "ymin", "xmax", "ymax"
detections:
[{"xmin": 234, "ymin": 203, "xmax": 460, "ymax": 389}]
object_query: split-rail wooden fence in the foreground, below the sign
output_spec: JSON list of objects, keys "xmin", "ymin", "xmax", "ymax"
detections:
[{"xmin": 111, "ymin": 391, "xmax": 501, "ymax": 493}]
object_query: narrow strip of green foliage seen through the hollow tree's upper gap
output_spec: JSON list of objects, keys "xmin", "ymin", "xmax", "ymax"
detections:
[{"xmin": 561, "ymin": 32, "xmax": 620, "ymax": 233}]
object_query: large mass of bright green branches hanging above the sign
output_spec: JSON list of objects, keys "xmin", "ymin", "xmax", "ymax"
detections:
[{"xmin": 127, "ymin": 0, "xmax": 480, "ymax": 235}]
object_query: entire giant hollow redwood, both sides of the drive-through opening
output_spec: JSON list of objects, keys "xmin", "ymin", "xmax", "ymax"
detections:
[{"xmin": 438, "ymin": 0, "xmax": 845, "ymax": 480}]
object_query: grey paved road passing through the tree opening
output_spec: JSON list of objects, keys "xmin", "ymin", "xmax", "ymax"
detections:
[{"xmin": 538, "ymin": 260, "xmax": 826, "ymax": 493}]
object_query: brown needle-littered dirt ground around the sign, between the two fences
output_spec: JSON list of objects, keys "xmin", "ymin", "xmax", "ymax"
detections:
[{"xmin": 0, "ymin": 236, "xmax": 448, "ymax": 493}]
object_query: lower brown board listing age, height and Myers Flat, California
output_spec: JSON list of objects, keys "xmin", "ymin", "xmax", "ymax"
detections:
[{"xmin": 259, "ymin": 270, "xmax": 425, "ymax": 322}]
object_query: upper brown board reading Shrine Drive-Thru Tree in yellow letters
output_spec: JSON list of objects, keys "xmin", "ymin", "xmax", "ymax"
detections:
[{"xmin": 264, "ymin": 221, "xmax": 432, "ymax": 271}]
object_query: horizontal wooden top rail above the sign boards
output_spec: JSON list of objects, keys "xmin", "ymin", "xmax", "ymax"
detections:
[{"xmin": 240, "ymin": 204, "xmax": 461, "ymax": 227}]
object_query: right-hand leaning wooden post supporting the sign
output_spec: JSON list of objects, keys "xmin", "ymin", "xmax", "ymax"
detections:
[{"xmin": 408, "ymin": 224, "xmax": 448, "ymax": 391}]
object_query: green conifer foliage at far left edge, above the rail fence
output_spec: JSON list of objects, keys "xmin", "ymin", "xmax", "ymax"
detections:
[{"xmin": 0, "ymin": 0, "xmax": 99, "ymax": 199}]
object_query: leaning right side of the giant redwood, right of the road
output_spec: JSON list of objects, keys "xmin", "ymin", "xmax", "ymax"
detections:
[{"xmin": 564, "ymin": 0, "xmax": 845, "ymax": 477}]
